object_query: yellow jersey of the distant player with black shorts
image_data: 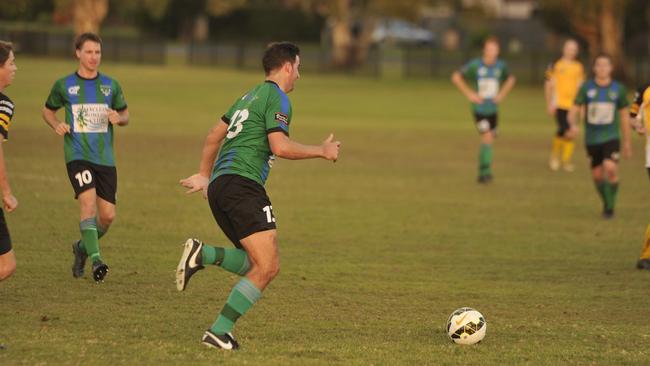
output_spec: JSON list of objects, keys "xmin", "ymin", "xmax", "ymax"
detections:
[{"xmin": 546, "ymin": 59, "xmax": 585, "ymax": 110}]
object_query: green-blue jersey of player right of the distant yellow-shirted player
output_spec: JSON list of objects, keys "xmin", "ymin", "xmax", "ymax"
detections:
[{"xmin": 575, "ymin": 79, "xmax": 629, "ymax": 145}]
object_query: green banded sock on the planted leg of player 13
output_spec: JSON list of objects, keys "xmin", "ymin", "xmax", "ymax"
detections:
[{"xmin": 210, "ymin": 277, "xmax": 262, "ymax": 334}]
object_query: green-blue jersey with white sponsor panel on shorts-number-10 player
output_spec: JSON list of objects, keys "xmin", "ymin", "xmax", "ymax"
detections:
[{"xmin": 45, "ymin": 72, "xmax": 126, "ymax": 166}]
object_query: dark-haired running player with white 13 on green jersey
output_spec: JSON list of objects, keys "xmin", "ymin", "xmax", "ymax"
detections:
[{"xmin": 176, "ymin": 42, "xmax": 340, "ymax": 350}]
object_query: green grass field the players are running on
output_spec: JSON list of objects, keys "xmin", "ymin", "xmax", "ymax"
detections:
[{"xmin": 0, "ymin": 57, "xmax": 650, "ymax": 365}]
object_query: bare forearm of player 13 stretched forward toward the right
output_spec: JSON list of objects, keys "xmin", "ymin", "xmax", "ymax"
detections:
[{"xmin": 268, "ymin": 132, "xmax": 341, "ymax": 161}]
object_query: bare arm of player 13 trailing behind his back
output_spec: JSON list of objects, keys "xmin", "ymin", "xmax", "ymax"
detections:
[{"xmin": 180, "ymin": 120, "xmax": 228, "ymax": 197}]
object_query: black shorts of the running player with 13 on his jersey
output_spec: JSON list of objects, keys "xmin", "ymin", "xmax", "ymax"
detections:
[{"xmin": 208, "ymin": 174, "xmax": 275, "ymax": 249}]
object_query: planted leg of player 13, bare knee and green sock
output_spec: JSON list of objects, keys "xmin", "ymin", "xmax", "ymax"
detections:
[{"xmin": 210, "ymin": 230, "xmax": 280, "ymax": 335}]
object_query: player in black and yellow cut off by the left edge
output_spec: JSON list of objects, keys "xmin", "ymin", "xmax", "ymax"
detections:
[{"xmin": 0, "ymin": 41, "xmax": 18, "ymax": 281}]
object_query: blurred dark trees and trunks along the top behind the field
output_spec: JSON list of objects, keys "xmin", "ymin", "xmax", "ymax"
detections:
[{"xmin": 0, "ymin": 0, "xmax": 650, "ymax": 74}]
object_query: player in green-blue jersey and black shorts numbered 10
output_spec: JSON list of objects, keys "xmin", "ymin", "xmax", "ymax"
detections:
[{"xmin": 43, "ymin": 33, "xmax": 129, "ymax": 282}]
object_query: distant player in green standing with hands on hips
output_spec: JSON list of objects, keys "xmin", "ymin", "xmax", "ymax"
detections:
[{"xmin": 451, "ymin": 37, "xmax": 515, "ymax": 183}]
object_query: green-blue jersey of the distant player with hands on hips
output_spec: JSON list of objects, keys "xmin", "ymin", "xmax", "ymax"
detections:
[{"xmin": 460, "ymin": 58, "xmax": 510, "ymax": 116}]
